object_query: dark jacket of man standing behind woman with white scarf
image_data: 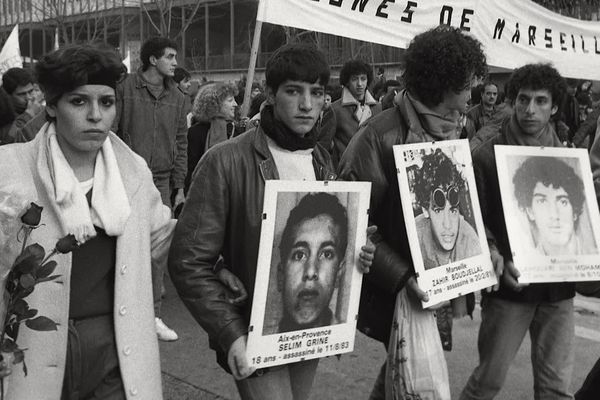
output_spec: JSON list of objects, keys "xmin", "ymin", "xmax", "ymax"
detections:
[{"xmin": 113, "ymin": 71, "xmax": 187, "ymax": 189}]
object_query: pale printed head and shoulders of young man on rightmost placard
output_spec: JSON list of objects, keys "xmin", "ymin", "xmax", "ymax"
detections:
[{"xmin": 513, "ymin": 157, "xmax": 596, "ymax": 256}]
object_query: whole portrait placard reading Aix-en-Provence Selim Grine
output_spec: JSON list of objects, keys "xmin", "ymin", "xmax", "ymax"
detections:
[{"xmin": 246, "ymin": 180, "xmax": 371, "ymax": 368}]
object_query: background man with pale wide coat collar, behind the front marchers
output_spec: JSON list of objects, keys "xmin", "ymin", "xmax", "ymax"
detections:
[{"xmin": 323, "ymin": 60, "xmax": 381, "ymax": 163}]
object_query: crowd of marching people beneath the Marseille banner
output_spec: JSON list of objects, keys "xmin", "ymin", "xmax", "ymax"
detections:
[{"xmin": 0, "ymin": 26, "xmax": 600, "ymax": 400}]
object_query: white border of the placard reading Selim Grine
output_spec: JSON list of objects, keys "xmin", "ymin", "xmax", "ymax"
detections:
[{"xmin": 246, "ymin": 180, "xmax": 371, "ymax": 368}]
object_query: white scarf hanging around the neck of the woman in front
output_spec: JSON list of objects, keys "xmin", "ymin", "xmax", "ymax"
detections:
[{"xmin": 41, "ymin": 123, "xmax": 131, "ymax": 243}]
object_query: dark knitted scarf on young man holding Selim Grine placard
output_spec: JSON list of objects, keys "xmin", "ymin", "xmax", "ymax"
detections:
[{"xmin": 260, "ymin": 105, "xmax": 318, "ymax": 151}]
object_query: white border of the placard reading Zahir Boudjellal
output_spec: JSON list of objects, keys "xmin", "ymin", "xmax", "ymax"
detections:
[{"xmin": 393, "ymin": 139, "xmax": 498, "ymax": 308}]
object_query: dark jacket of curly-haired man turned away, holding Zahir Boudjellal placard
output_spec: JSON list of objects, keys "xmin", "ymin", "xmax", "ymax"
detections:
[{"xmin": 339, "ymin": 107, "xmax": 425, "ymax": 344}]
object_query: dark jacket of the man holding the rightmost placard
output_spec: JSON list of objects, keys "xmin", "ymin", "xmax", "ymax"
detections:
[{"xmin": 472, "ymin": 123, "xmax": 575, "ymax": 302}]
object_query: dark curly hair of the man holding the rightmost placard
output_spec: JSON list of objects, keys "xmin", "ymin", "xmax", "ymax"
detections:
[{"xmin": 506, "ymin": 63, "xmax": 567, "ymax": 106}]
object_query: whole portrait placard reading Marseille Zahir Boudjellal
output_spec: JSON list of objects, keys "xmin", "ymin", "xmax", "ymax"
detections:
[{"xmin": 394, "ymin": 140, "xmax": 497, "ymax": 307}]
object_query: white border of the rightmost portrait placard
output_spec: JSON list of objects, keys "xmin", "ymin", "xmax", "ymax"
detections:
[{"xmin": 494, "ymin": 145, "xmax": 600, "ymax": 283}]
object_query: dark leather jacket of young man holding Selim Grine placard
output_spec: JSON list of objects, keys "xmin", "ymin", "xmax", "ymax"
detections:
[{"xmin": 169, "ymin": 126, "xmax": 335, "ymax": 370}]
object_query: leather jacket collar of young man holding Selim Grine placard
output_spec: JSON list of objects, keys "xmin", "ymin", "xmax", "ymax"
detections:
[{"xmin": 251, "ymin": 125, "xmax": 337, "ymax": 181}]
